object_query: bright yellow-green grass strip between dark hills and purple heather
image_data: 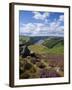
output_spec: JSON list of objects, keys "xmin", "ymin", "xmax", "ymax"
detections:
[{"xmin": 29, "ymin": 44, "xmax": 64, "ymax": 54}]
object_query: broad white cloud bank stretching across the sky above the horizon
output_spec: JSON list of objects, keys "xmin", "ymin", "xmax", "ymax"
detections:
[{"xmin": 20, "ymin": 21, "xmax": 64, "ymax": 36}]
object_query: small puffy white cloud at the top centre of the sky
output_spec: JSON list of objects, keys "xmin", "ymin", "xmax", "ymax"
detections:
[{"xmin": 33, "ymin": 12, "xmax": 50, "ymax": 20}]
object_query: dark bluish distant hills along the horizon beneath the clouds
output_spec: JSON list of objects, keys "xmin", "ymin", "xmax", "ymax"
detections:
[{"xmin": 19, "ymin": 36, "xmax": 63, "ymax": 46}]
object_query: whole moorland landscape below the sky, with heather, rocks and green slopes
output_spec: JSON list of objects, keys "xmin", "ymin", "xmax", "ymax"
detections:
[{"xmin": 19, "ymin": 36, "xmax": 64, "ymax": 79}]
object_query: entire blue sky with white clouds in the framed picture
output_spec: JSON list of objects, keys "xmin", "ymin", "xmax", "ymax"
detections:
[{"xmin": 19, "ymin": 11, "xmax": 64, "ymax": 37}]
